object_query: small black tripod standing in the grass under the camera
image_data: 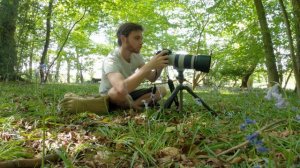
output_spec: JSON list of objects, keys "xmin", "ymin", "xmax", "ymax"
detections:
[{"xmin": 164, "ymin": 69, "xmax": 217, "ymax": 115}]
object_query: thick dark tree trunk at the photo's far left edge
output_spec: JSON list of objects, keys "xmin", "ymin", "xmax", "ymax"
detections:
[{"xmin": 0, "ymin": 0, "xmax": 19, "ymax": 80}]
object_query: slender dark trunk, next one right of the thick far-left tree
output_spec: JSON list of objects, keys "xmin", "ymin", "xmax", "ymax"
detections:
[{"xmin": 40, "ymin": 0, "xmax": 54, "ymax": 83}]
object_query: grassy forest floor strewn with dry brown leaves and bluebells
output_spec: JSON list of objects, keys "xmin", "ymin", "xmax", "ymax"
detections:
[{"xmin": 0, "ymin": 83, "xmax": 300, "ymax": 167}]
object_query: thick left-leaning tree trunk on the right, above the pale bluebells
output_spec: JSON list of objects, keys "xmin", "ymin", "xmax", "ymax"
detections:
[{"xmin": 254, "ymin": 0, "xmax": 279, "ymax": 86}]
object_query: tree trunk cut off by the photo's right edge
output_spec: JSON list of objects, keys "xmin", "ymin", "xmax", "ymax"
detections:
[{"xmin": 291, "ymin": 0, "xmax": 300, "ymax": 98}]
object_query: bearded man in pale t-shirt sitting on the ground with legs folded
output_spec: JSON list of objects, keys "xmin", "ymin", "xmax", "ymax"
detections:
[{"xmin": 61, "ymin": 23, "xmax": 168, "ymax": 113}]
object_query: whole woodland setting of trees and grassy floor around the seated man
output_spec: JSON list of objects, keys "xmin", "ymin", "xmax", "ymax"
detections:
[{"xmin": 0, "ymin": 0, "xmax": 300, "ymax": 168}]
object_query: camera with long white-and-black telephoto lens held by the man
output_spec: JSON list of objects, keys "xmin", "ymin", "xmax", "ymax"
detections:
[{"xmin": 156, "ymin": 49, "xmax": 211, "ymax": 73}]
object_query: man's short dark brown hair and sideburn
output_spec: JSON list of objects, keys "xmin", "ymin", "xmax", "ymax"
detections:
[{"xmin": 117, "ymin": 22, "xmax": 144, "ymax": 46}]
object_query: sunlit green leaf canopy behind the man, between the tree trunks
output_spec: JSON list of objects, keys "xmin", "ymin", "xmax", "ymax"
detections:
[{"xmin": 5, "ymin": 0, "xmax": 291, "ymax": 82}]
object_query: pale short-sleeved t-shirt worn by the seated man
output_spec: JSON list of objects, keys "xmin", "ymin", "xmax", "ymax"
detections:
[{"xmin": 99, "ymin": 48, "xmax": 145, "ymax": 94}]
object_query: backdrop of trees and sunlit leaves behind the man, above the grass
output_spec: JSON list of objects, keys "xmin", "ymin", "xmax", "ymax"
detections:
[{"xmin": 0, "ymin": 0, "xmax": 300, "ymax": 95}]
